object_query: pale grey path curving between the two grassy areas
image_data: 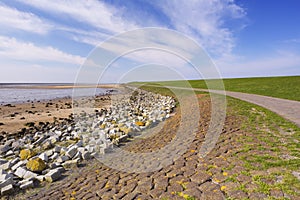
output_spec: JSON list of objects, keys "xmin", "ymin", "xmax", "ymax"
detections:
[{"xmin": 164, "ymin": 87, "xmax": 300, "ymax": 127}]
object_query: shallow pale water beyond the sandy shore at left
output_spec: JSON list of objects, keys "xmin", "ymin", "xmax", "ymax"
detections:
[{"xmin": 0, "ymin": 84, "xmax": 109, "ymax": 104}]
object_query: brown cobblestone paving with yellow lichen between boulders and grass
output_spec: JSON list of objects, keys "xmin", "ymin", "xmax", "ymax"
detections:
[{"xmin": 10, "ymin": 94, "xmax": 299, "ymax": 200}]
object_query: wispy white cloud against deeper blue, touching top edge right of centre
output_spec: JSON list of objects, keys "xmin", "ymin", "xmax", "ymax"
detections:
[{"xmin": 155, "ymin": 0, "xmax": 245, "ymax": 57}]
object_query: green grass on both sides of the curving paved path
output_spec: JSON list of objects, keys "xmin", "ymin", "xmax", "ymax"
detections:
[{"xmin": 141, "ymin": 84, "xmax": 300, "ymax": 199}]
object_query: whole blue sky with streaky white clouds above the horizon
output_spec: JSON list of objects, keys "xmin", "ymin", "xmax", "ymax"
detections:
[{"xmin": 0, "ymin": 0, "xmax": 300, "ymax": 82}]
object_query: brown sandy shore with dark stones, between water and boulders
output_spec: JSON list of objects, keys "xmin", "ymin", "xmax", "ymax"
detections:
[{"xmin": 0, "ymin": 95, "xmax": 110, "ymax": 134}]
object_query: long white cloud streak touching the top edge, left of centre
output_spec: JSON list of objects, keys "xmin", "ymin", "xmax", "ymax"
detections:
[{"xmin": 22, "ymin": 0, "xmax": 137, "ymax": 33}]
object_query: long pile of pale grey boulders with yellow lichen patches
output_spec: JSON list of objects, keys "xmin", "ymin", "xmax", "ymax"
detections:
[{"xmin": 0, "ymin": 90, "xmax": 175, "ymax": 195}]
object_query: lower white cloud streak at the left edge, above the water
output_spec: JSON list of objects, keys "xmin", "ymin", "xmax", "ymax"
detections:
[{"xmin": 0, "ymin": 36, "xmax": 84, "ymax": 65}]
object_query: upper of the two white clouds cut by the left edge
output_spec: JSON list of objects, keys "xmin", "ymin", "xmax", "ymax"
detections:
[{"xmin": 0, "ymin": 4, "xmax": 52, "ymax": 34}]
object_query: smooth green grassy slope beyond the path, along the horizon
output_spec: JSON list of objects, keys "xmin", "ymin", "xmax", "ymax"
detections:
[{"xmin": 138, "ymin": 76, "xmax": 300, "ymax": 101}]
